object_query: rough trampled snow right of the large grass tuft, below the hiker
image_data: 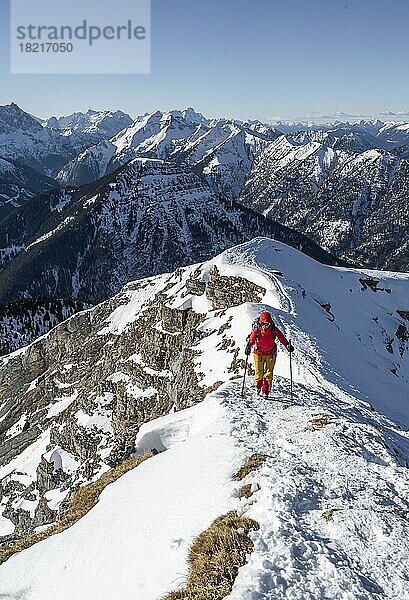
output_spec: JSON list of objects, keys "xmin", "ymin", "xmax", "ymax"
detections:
[{"xmin": 222, "ymin": 378, "xmax": 409, "ymax": 600}]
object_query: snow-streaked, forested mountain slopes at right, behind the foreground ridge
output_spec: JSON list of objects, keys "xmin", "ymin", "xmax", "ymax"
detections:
[{"xmin": 239, "ymin": 132, "xmax": 409, "ymax": 271}]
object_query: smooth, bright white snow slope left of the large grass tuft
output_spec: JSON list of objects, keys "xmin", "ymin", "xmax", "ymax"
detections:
[{"xmin": 0, "ymin": 400, "xmax": 243, "ymax": 600}]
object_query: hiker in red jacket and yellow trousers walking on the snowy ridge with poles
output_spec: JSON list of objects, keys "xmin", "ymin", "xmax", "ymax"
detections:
[{"xmin": 245, "ymin": 310, "xmax": 294, "ymax": 398}]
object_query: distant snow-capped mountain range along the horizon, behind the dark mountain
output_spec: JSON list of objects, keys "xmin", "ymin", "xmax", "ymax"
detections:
[{"xmin": 0, "ymin": 104, "xmax": 409, "ymax": 270}]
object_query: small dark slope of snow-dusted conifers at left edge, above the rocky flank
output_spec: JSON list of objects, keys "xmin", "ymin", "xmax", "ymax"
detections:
[{"xmin": 0, "ymin": 296, "xmax": 90, "ymax": 355}]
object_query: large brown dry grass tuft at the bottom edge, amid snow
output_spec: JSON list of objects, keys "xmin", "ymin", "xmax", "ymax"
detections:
[{"xmin": 164, "ymin": 512, "xmax": 259, "ymax": 600}]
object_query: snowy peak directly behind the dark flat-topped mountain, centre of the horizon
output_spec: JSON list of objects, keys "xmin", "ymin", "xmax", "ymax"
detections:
[{"xmin": 58, "ymin": 108, "xmax": 279, "ymax": 197}]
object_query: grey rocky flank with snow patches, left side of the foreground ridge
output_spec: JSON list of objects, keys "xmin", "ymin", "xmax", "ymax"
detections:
[{"xmin": 0, "ymin": 267, "xmax": 265, "ymax": 544}]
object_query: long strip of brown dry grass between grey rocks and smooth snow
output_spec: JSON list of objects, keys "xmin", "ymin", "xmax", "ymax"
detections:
[{"xmin": 0, "ymin": 452, "xmax": 154, "ymax": 565}]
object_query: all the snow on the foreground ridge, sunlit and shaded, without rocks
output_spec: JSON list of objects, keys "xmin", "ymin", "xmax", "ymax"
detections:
[{"xmin": 0, "ymin": 238, "xmax": 409, "ymax": 600}]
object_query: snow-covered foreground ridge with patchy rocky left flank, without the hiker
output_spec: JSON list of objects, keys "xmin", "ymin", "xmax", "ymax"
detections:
[{"xmin": 0, "ymin": 238, "xmax": 409, "ymax": 600}]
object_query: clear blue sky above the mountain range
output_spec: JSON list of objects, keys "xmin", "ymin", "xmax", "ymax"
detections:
[{"xmin": 0, "ymin": 0, "xmax": 409, "ymax": 120}]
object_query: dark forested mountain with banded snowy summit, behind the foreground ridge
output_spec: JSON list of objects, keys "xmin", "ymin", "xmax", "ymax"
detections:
[{"xmin": 0, "ymin": 158, "xmax": 341, "ymax": 303}]
